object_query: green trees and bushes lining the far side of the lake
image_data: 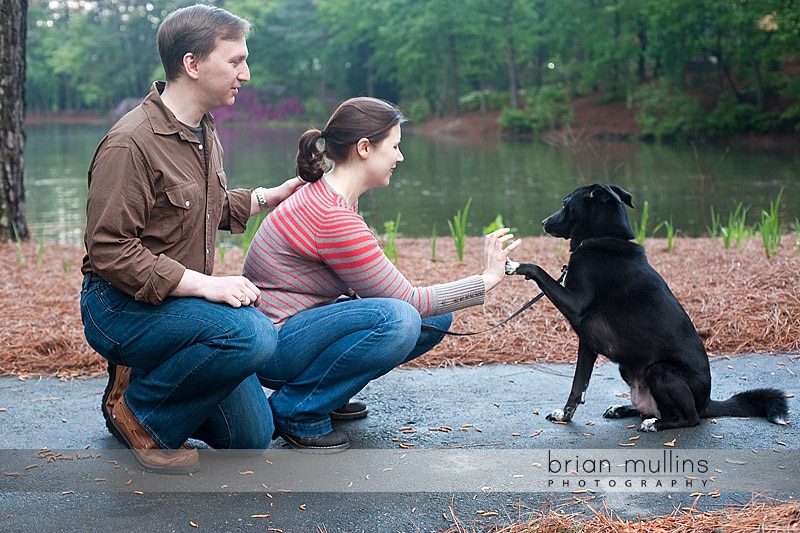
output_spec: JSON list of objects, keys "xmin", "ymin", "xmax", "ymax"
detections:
[{"xmin": 21, "ymin": 0, "xmax": 800, "ymax": 140}]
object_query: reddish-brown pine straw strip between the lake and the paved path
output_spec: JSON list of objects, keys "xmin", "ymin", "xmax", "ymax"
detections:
[{"xmin": 0, "ymin": 235, "xmax": 800, "ymax": 378}]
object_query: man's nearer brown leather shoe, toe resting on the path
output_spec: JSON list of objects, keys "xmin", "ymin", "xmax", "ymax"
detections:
[{"xmin": 109, "ymin": 397, "xmax": 200, "ymax": 474}]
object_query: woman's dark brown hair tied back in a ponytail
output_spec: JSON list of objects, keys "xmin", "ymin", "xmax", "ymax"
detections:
[{"xmin": 296, "ymin": 96, "xmax": 405, "ymax": 181}]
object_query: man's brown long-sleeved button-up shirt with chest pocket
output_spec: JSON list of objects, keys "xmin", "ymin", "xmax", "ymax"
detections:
[{"xmin": 82, "ymin": 82, "xmax": 251, "ymax": 304}]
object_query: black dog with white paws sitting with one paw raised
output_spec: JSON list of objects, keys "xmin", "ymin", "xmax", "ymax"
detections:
[{"xmin": 506, "ymin": 184, "xmax": 788, "ymax": 431}]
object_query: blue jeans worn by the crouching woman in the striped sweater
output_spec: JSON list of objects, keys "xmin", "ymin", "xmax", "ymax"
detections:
[{"xmin": 258, "ymin": 298, "xmax": 453, "ymax": 437}]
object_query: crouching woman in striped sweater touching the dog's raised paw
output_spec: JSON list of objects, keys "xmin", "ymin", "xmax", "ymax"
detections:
[{"xmin": 243, "ymin": 97, "xmax": 519, "ymax": 453}]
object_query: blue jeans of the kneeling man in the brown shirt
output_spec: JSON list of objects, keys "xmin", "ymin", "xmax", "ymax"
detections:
[{"xmin": 81, "ymin": 276, "xmax": 277, "ymax": 449}]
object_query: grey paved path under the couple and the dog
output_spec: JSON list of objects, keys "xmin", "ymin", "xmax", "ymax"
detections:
[{"xmin": 0, "ymin": 355, "xmax": 800, "ymax": 533}]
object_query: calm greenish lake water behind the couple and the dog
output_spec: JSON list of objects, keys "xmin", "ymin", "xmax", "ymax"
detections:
[{"xmin": 26, "ymin": 124, "xmax": 800, "ymax": 244}]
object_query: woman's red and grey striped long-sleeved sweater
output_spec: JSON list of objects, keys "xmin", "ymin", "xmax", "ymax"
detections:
[{"xmin": 242, "ymin": 178, "xmax": 486, "ymax": 326}]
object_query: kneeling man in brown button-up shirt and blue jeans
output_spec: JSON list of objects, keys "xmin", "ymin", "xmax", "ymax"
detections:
[{"xmin": 81, "ymin": 5, "xmax": 302, "ymax": 473}]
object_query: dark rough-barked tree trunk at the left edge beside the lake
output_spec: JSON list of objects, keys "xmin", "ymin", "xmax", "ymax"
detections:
[{"xmin": 0, "ymin": 0, "xmax": 29, "ymax": 241}]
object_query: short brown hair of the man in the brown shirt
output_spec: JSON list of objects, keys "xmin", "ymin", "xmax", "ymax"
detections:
[{"xmin": 158, "ymin": 4, "xmax": 252, "ymax": 81}]
